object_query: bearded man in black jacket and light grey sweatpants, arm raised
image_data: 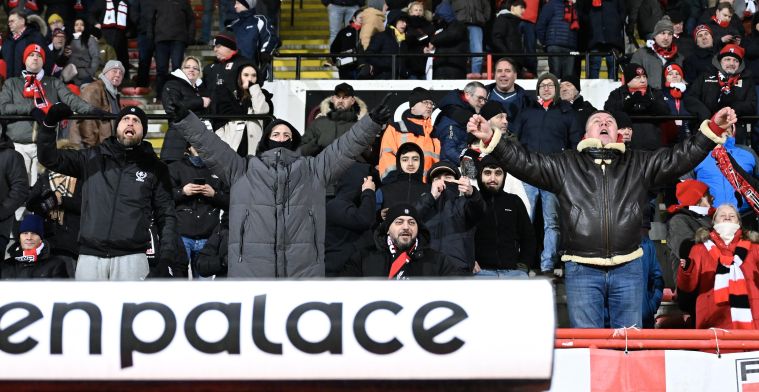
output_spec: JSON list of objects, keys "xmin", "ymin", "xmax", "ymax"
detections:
[{"xmin": 32, "ymin": 103, "xmax": 177, "ymax": 280}]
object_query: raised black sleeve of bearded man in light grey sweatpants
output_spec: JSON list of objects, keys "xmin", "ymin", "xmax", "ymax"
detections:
[{"xmin": 36, "ymin": 127, "xmax": 89, "ymax": 181}]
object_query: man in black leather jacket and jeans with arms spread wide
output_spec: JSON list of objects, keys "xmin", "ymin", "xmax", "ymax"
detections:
[{"xmin": 467, "ymin": 108, "xmax": 737, "ymax": 328}]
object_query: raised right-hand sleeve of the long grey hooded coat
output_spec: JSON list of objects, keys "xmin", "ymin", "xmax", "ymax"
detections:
[{"xmin": 310, "ymin": 116, "xmax": 380, "ymax": 184}]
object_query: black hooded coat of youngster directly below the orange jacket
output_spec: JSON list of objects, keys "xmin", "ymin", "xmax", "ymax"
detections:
[{"xmin": 377, "ymin": 143, "xmax": 430, "ymax": 209}]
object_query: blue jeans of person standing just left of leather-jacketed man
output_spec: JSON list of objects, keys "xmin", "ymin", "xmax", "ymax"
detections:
[{"xmin": 524, "ymin": 183, "xmax": 559, "ymax": 272}]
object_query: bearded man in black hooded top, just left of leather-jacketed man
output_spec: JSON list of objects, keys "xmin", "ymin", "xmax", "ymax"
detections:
[{"xmin": 474, "ymin": 155, "xmax": 537, "ymax": 279}]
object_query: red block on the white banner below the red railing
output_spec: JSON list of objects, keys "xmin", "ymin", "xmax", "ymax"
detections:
[{"xmin": 590, "ymin": 349, "xmax": 664, "ymax": 392}]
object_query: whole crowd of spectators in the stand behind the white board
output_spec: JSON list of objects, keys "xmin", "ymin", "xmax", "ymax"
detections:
[{"xmin": 0, "ymin": 0, "xmax": 759, "ymax": 334}]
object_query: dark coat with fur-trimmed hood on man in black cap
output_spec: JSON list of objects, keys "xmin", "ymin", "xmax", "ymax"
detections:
[{"xmin": 300, "ymin": 97, "xmax": 367, "ymax": 157}]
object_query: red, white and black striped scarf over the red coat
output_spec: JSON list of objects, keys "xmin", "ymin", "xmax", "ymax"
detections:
[{"xmin": 704, "ymin": 230, "xmax": 754, "ymax": 329}]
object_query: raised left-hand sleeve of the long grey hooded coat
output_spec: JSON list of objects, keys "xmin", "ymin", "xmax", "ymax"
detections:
[{"xmin": 174, "ymin": 112, "xmax": 246, "ymax": 187}]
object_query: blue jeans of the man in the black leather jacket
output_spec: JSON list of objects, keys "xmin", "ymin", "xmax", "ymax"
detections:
[{"xmin": 564, "ymin": 258, "xmax": 646, "ymax": 328}]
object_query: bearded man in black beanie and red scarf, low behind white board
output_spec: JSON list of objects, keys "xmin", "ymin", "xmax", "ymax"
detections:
[{"xmin": 343, "ymin": 203, "xmax": 462, "ymax": 280}]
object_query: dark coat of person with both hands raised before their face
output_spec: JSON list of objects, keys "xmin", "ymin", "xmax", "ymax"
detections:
[{"xmin": 415, "ymin": 178, "xmax": 485, "ymax": 274}]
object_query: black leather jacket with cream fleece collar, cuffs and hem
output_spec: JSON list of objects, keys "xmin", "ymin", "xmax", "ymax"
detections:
[{"xmin": 483, "ymin": 123, "xmax": 718, "ymax": 265}]
